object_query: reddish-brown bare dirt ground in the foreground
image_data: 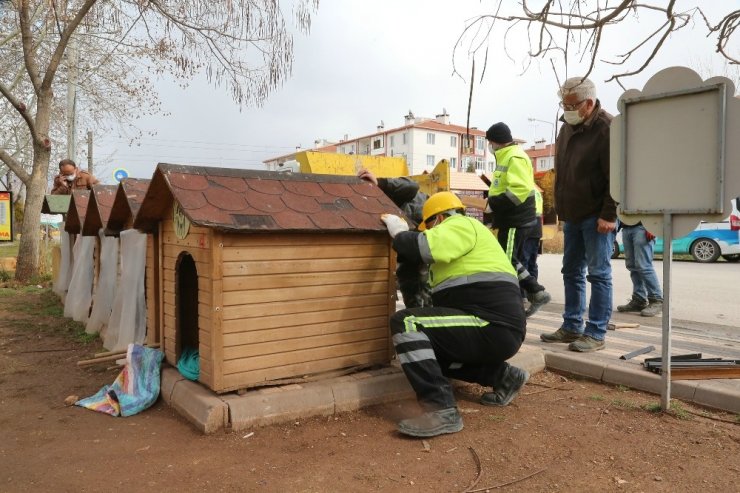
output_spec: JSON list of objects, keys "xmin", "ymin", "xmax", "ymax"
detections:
[{"xmin": 0, "ymin": 286, "xmax": 740, "ymax": 492}]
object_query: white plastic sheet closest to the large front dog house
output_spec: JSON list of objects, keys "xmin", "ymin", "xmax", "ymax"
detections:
[{"xmin": 103, "ymin": 230, "xmax": 146, "ymax": 351}]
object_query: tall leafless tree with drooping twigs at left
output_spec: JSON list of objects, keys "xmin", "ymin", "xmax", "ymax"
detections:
[{"xmin": 0, "ymin": 0, "xmax": 318, "ymax": 281}]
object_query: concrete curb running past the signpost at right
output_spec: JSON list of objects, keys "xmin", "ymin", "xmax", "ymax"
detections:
[{"xmin": 544, "ymin": 351, "xmax": 740, "ymax": 413}]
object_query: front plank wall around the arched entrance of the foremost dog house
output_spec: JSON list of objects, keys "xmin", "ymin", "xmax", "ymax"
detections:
[{"xmin": 159, "ymin": 209, "xmax": 215, "ymax": 390}]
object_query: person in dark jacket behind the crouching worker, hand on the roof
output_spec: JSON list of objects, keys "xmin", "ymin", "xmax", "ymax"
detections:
[{"xmin": 357, "ymin": 168, "xmax": 432, "ymax": 308}]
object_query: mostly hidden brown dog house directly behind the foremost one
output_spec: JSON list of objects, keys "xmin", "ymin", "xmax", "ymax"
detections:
[{"xmin": 105, "ymin": 178, "xmax": 161, "ymax": 345}]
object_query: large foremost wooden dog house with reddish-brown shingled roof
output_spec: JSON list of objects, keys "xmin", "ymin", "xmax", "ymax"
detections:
[{"xmin": 134, "ymin": 164, "xmax": 400, "ymax": 392}]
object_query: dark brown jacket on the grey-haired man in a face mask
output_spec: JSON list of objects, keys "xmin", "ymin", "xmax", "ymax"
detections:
[{"xmin": 555, "ymin": 100, "xmax": 617, "ymax": 222}]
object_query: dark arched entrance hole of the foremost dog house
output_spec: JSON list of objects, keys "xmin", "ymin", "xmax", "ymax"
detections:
[{"xmin": 175, "ymin": 253, "xmax": 198, "ymax": 360}]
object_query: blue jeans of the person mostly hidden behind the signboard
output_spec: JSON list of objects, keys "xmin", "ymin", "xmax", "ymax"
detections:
[{"xmin": 622, "ymin": 224, "xmax": 663, "ymax": 301}]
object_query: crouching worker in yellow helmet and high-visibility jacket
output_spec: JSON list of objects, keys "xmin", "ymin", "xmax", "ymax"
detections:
[{"xmin": 381, "ymin": 192, "xmax": 529, "ymax": 437}]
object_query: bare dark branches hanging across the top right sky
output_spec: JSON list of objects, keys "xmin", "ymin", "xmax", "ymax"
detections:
[{"xmin": 452, "ymin": 0, "xmax": 740, "ymax": 88}]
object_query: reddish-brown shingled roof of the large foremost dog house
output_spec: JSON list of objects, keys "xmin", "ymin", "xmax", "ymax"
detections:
[{"xmin": 134, "ymin": 164, "xmax": 401, "ymax": 232}]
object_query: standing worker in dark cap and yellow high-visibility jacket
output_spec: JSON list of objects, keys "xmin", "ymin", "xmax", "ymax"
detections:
[{"xmin": 486, "ymin": 122, "xmax": 551, "ymax": 317}]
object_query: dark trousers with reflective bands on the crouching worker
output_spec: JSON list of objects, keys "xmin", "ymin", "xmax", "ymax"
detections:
[{"xmin": 390, "ymin": 307, "xmax": 524, "ymax": 411}]
